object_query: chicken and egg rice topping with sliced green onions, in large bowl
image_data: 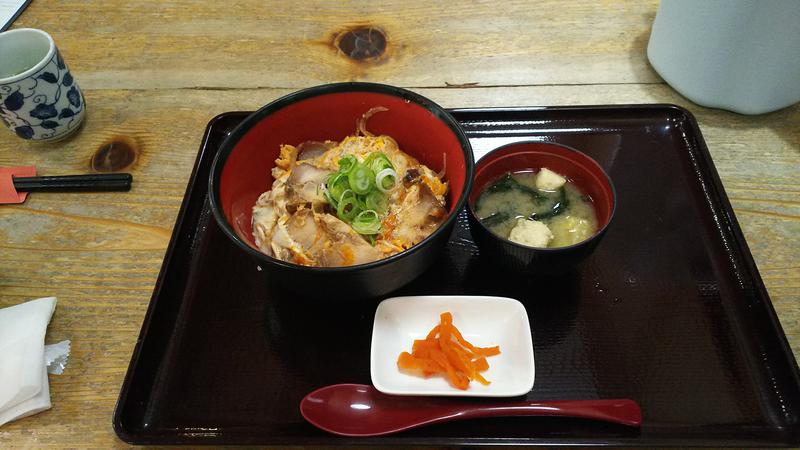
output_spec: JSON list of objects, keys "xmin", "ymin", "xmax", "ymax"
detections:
[{"xmin": 252, "ymin": 107, "xmax": 448, "ymax": 267}]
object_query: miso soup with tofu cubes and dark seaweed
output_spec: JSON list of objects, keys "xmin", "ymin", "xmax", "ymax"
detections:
[{"xmin": 475, "ymin": 168, "xmax": 598, "ymax": 248}]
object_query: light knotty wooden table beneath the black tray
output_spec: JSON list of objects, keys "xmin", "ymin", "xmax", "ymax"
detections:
[{"xmin": 0, "ymin": 0, "xmax": 800, "ymax": 448}]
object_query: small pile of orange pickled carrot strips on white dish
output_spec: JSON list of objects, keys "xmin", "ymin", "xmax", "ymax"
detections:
[{"xmin": 397, "ymin": 312, "xmax": 500, "ymax": 390}]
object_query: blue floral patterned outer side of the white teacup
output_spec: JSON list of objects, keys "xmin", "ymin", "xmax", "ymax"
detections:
[{"xmin": 0, "ymin": 51, "xmax": 85, "ymax": 141}]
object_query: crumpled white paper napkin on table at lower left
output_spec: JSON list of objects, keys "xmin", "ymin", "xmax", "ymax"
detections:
[{"xmin": 0, "ymin": 297, "xmax": 63, "ymax": 426}]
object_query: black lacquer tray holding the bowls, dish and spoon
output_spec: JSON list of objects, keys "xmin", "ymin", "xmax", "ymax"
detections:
[{"xmin": 114, "ymin": 105, "xmax": 800, "ymax": 447}]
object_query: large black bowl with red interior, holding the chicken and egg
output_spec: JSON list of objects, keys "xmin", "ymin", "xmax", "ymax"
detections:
[{"xmin": 209, "ymin": 83, "xmax": 474, "ymax": 299}]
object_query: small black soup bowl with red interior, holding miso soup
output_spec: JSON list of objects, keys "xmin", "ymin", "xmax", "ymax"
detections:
[{"xmin": 467, "ymin": 141, "xmax": 616, "ymax": 275}]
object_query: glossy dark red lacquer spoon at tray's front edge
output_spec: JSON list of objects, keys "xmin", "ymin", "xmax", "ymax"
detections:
[{"xmin": 300, "ymin": 384, "xmax": 642, "ymax": 436}]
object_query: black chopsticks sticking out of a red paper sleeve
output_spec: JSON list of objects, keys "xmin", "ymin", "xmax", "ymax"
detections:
[{"xmin": 12, "ymin": 173, "xmax": 133, "ymax": 192}]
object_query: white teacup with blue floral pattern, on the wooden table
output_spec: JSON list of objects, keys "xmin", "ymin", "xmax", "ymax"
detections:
[{"xmin": 0, "ymin": 28, "xmax": 86, "ymax": 142}]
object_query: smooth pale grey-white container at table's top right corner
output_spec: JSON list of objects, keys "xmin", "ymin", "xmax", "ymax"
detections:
[{"xmin": 647, "ymin": 0, "xmax": 800, "ymax": 114}]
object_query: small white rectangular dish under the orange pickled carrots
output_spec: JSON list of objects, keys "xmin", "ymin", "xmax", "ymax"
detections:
[{"xmin": 370, "ymin": 296, "xmax": 535, "ymax": 397}]
